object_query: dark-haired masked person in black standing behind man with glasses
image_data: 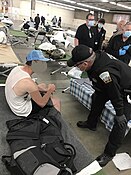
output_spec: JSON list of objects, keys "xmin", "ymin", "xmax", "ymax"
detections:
[{"xmin": 92, "ymin": 18, "xmax": 106, "ymax": 51}]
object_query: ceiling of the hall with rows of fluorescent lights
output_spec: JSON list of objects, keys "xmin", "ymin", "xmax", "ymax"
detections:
[{"xmin": 41, "ymin": 0, "xmax": 131, "ymax": 14}]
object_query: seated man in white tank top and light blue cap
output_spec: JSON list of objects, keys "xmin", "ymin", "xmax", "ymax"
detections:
[{"xmin": 5, "ymin": 50, "xmax": 60, "ymax": 117}]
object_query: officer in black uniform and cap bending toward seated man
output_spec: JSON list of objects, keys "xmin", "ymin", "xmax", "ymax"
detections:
[{"xmin": 67, "ymin": 45, "xmax": 131, "ymax": 167}]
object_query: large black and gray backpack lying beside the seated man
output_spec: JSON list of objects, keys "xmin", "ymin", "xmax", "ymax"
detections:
[{"xmin": 2, "ymin": 114, "xmax": 76, "ymax": 175}]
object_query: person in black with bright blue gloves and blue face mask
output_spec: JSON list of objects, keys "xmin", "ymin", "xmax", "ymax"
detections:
[{"xmin": 106, "ymin": 22, "xmax": 131, "ymax": 64}]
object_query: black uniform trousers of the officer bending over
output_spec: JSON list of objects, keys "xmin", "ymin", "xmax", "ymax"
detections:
[{"xmin": 87, "ymin": 91, "xmax": 128, "ymax": 157}]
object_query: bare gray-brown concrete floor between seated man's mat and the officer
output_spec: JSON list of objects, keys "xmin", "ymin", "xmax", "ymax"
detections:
[{"xmin": 10, "ymin": 38, "xmax": 131, "ymax": 175}]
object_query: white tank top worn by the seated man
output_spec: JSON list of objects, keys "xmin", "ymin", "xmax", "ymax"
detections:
[{"xmin": 5, "ymin": 66, "xmax": 32, "ymax": 117}]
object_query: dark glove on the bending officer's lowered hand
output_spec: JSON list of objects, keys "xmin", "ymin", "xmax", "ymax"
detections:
[{"xmin": 115, "ymin": 114, "xmax": 127, "ymax": 129}]
